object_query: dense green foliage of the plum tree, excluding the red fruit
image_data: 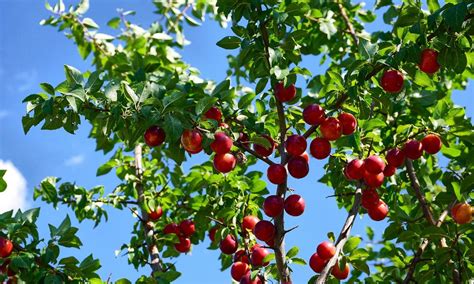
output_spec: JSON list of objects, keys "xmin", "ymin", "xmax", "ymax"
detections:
[{"xmin": 0, "ymin": 0, "xmax": 474, "ymax": 283}]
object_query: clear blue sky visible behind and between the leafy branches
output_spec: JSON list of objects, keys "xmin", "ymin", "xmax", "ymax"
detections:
[{"xmin": 0, "ymin": 0, "xmax": 474, "ymax": 283}]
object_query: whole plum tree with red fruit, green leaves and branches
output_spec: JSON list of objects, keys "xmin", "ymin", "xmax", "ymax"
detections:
[{"xmin": 0, "ymin": 0, "xmax": 474, "ymax": 283}]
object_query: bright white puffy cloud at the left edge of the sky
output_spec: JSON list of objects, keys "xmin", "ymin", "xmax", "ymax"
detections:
[{"xmin": 0, "ymin": 160, "xmax": 29, "ymax": 212}]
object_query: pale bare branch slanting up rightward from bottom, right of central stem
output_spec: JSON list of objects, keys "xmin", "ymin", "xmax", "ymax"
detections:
[{"xmin": 315, "ymin": 186, "xmax": 362, "ymax": 284}]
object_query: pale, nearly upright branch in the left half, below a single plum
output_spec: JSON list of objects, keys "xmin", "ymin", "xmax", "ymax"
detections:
[{"xmin": 135, "ymin": 144, "xmax": 163, "ymax": 274}]
